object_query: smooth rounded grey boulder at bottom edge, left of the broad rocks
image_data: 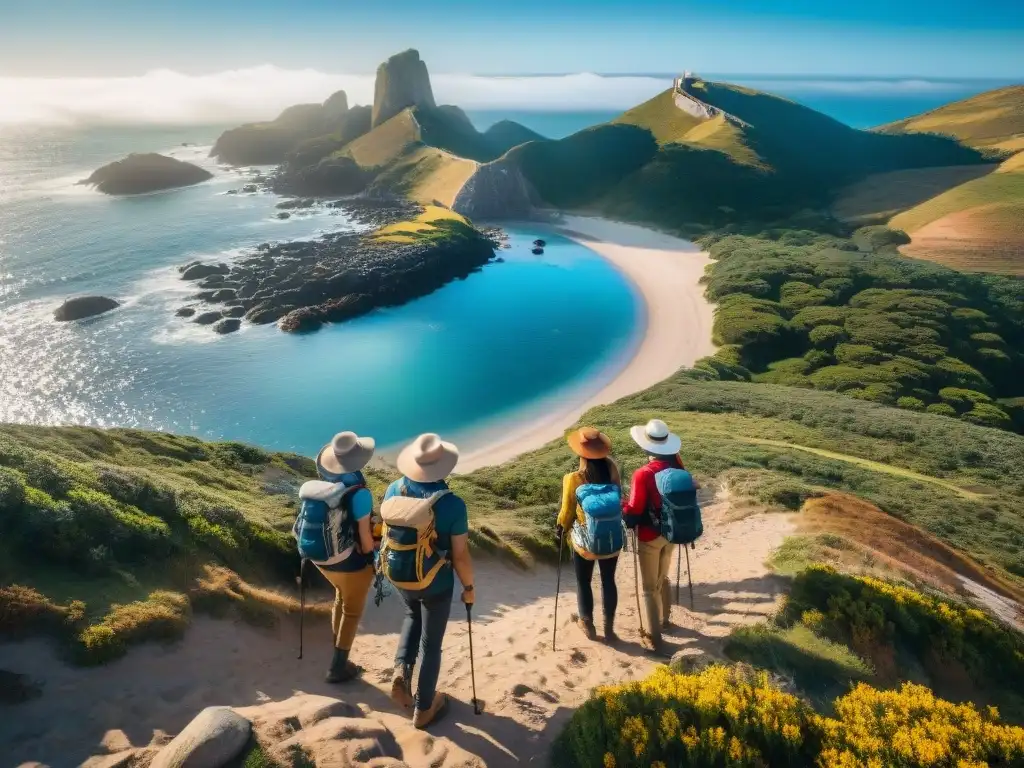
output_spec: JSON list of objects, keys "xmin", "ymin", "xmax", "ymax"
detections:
[{"xmin": 150, "ymin": 707, "xmax": 252, "ymax": 768}]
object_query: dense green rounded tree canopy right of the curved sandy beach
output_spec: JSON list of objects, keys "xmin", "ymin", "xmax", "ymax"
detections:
[{"xmin": 707, "ymin": 227, "xmax": 1024, "ymax": 430}]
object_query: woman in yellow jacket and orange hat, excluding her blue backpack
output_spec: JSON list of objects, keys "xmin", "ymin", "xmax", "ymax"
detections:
[{"xmin": 556, "ymin": 427, "xmax": 622, "ymax": 643}]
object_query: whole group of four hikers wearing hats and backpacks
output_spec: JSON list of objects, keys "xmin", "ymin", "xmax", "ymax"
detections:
[{"xmin": 293, "ymin": 419, "xmax": 702, "ymax": 728}]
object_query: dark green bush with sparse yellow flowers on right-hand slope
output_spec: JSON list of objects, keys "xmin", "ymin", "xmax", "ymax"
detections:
[{"xmin": 785, "ymin": 565, "xmax": 1024, "ymax": 682}]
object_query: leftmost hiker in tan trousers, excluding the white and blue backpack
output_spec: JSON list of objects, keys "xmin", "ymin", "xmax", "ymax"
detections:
[{"xmin": 315, "ymin": 432, "xmax": 376, "ymax": 683}]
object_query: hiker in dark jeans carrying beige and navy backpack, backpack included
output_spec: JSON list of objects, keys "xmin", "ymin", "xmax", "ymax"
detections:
[{"xmin": 379, "ymin": 433, "xmax": 475, "ymax": 728}]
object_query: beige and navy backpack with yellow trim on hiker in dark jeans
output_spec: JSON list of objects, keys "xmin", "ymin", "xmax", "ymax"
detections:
[{"xmin": 378, "ymin": 484, "xmax": 452, "ymax": 590}]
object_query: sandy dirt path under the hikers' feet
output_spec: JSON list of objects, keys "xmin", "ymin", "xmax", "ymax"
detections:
[{"xmin": 0, "ymin": 503, "xmax": 793, "ymax": 768}]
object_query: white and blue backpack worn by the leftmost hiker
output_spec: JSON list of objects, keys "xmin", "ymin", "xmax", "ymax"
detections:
[{"xmin": 292, "ymin": 480, "xmax": 366, "ymax": 565}]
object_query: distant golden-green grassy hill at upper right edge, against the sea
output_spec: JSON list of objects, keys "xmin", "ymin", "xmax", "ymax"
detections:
[{"xmin": 877, "ymin": 85, "xmax": 1024, "ymax": 152}]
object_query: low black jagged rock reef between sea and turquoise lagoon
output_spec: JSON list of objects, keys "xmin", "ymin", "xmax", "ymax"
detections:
[{"xmin": 182, "ymin": 201, "xmax": 495, "ymax": 332}]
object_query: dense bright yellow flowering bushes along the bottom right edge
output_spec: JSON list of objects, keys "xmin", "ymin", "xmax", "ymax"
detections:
[{"xmin": 553, "ymin": 667, "xmax": 1024, "ymax": 768}]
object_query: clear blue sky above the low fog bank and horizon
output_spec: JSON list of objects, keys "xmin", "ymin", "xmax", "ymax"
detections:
[{"xmin": 0, "ymin": 0, "xmax": 1024, "ymax": 80}]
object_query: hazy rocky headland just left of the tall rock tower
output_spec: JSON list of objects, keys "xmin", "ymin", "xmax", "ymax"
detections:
[{"xmin": 210, "ymin": 91, "xmax": 356, "ymax": 165}]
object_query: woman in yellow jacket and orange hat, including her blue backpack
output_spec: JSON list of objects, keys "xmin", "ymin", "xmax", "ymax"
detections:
[{"xmin": 556, "ymin": 427, "xmax": 623, "ymax": 643}]
